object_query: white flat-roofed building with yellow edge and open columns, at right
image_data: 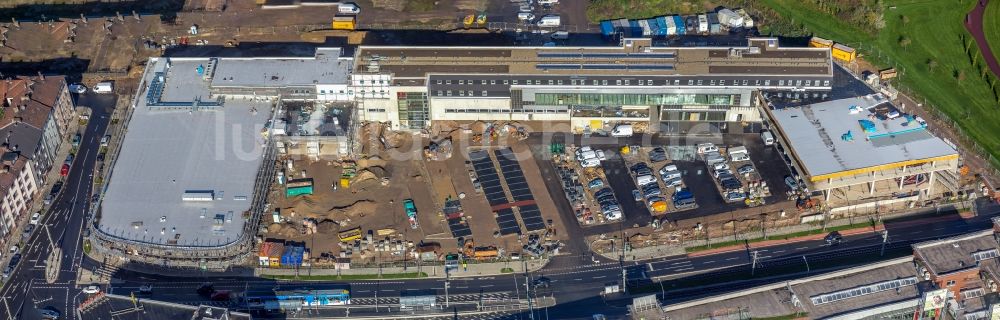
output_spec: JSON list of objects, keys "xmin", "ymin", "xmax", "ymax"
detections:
[{"xmin": 761, "ymin": 94, "xmax": 959, "ymax": 211}]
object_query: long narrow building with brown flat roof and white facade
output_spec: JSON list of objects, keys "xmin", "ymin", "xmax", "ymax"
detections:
[{"xmin": 352, "ymin": 38, "xmax": 834, "ymax": 132}]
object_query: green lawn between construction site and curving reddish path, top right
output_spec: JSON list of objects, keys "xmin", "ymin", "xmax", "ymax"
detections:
[{"xmin": 758, "ymin": 0, "xmax": 1000, "ymax": 166}]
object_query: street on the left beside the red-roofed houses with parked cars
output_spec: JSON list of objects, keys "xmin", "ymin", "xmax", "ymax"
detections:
[{"xmin": 0, "ymin": 95, "xmax": 117, "ymax": 319}]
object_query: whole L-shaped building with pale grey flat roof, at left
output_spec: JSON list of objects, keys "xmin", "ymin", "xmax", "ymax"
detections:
[{"xmin": 96, "ymin": 48, "xmax": 352, "ymax": 261}]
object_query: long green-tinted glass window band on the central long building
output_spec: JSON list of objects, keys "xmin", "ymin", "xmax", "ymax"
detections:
[{"xmin": 535, "ymin": 93, "xmax": 740, "ymax": 106}]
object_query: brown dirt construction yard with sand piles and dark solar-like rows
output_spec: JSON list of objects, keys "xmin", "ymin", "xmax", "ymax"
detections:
[{"xmin": 261, "ymin": 122, "xmax": 564, "ymax": 267}]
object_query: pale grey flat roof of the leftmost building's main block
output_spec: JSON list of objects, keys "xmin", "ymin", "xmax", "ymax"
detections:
[{"xmin": 99, "ymin": 59, "xmax": 271, "ymax": 247}]
